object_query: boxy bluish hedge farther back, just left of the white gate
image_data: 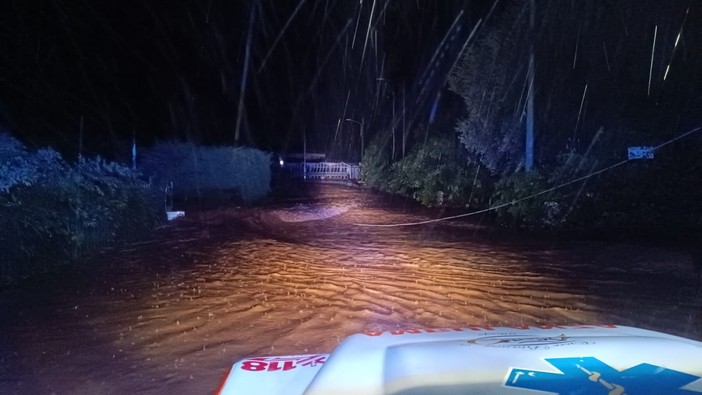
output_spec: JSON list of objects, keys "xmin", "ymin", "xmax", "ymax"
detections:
[{"xmin": 141, "ymin": 143, "xmax": 271, "ymax": 202}]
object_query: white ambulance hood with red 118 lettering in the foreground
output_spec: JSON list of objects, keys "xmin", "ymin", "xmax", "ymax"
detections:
[{"xmin": 219, "ymin": 325, "xmax": 702, "ymax": 395}]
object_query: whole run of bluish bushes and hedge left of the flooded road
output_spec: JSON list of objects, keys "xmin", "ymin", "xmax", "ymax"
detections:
[{"xmin": 0, "ymin": 133, "xmax": 270, "ymax": 286}]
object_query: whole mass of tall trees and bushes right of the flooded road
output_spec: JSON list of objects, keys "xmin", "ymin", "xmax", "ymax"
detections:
[{"xmin": 363, "ymin": 1, "xmax": 702, "ymax": 228}]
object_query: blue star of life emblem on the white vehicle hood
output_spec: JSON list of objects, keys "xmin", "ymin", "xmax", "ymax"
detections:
[{"xmin": 505, "ymin": 357, "xmax": 700, "ymax": 395}]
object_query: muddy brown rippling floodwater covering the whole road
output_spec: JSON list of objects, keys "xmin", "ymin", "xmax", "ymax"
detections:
[{"xmin": 0, "ymin": 185, "xmax": 702, "ymax": 394}]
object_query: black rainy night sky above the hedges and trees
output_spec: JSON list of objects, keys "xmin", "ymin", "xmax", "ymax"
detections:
[{"xmin": 0, "ymin": 0, "xmax": 702, "ymax": 158}]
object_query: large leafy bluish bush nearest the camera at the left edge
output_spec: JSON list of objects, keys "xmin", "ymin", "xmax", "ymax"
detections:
[{"xmin": 0, "ymin": 134, "xmax": 163, "ymax": 283}]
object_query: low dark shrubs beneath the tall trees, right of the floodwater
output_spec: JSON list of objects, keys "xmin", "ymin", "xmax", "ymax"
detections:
[{"xmin": 362, "ymin": 127, "xmax": 702, "ymax": 228}]
